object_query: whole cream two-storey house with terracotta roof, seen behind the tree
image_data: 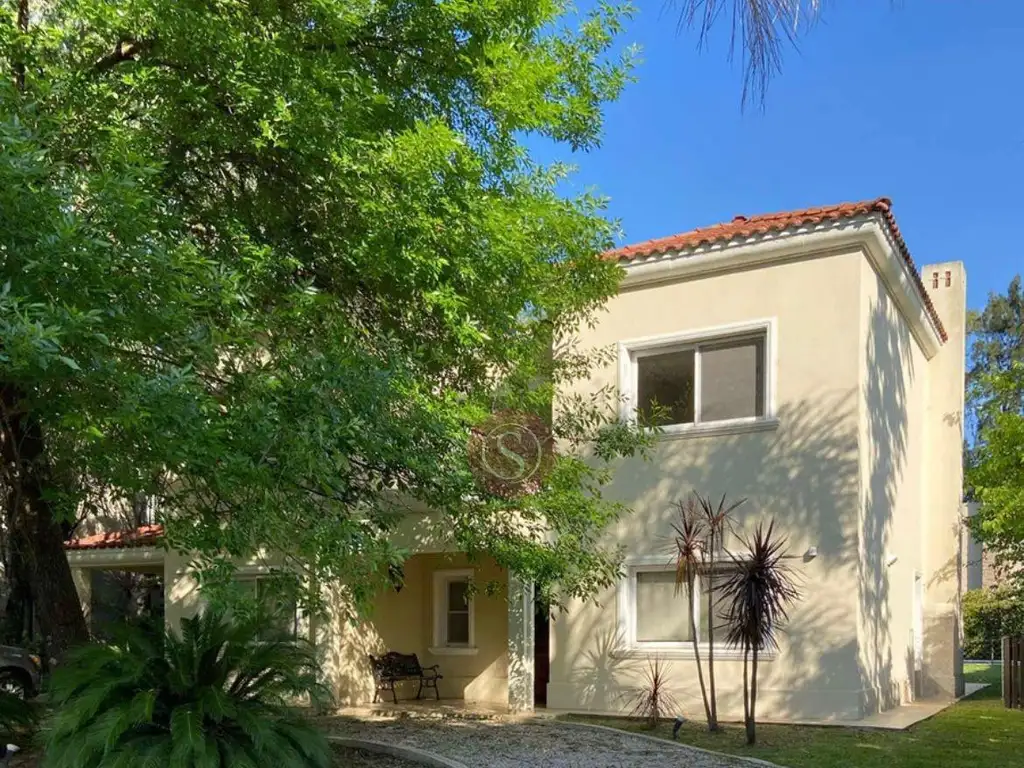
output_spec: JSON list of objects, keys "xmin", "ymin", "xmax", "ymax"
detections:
[{"xmin": 69, "ymin": 200, "xmax": 966, "ymax": 719}]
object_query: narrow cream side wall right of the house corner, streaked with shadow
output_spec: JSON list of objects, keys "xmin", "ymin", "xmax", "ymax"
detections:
[{"xmin": 857, "ymin": 259, "xmax": 929, "ymax": 714}]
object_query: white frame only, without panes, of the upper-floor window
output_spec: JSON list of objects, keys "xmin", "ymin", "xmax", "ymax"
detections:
[{"xmin": 618, "ymin": 317, "xmax": 778, "ymax": 436}]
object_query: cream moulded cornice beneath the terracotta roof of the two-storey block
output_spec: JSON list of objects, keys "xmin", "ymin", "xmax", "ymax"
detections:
[{"xmin": 621, "ymin": 213, "xmax": 942, "ymax": 359}]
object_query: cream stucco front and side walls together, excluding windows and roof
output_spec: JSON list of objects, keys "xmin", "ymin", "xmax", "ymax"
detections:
[{"xmin": 548, "ymin": 234, "xmax": 964, "ymax": 719}]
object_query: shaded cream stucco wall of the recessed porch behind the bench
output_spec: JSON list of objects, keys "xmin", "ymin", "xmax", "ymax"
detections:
[{"xmin": 315, "ymin": 553, "xmax": 509, "ymax": 706}]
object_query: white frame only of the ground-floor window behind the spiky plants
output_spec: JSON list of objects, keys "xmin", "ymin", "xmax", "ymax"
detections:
[{"xmin": 618, "ymin": 552, "xmax": 775, "ymax": 660}]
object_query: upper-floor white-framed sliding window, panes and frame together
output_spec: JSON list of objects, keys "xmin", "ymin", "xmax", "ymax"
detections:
[{"xmin": 620, "ymin": 319, "xmax": 776, "ymax": 434}]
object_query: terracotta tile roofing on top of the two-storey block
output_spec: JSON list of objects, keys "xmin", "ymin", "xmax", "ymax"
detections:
[{"xmin": 604, "ymin": 198, "xmax": 947, "ymax": 341}]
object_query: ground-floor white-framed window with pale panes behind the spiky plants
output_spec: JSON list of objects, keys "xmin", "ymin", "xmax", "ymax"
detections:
[{"xmin": 618, "ymin": 558, "xmax": 740, "ymax": 656}]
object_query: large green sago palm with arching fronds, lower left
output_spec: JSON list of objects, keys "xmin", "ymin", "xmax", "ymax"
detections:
[{"xmin": 44, "ymin": 609, "xmax": 331, "ymax": 768}]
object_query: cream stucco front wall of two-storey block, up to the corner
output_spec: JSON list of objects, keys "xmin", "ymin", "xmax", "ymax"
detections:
[{"xmin": 548, "ymin": 247, "xmax": 864, "ymax": 718}]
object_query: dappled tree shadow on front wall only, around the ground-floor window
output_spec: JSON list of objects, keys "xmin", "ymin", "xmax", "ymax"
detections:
[{"xmin": 554, "ymin": 391, "xmax": 860, "ymax": 717}]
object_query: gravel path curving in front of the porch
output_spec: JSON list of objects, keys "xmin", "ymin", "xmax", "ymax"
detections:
[{"xmin": 322, "ymin": 718, "xmax": 750, "ymax": 768}]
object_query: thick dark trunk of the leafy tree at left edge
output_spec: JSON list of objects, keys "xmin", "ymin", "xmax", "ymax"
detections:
[{"xmin": 0, "ymin": 384, "xmax": 89, "ymax": 659}]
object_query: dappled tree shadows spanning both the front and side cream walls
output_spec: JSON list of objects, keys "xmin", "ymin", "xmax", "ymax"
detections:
[{"xmin": 554, "ymin": 292, "xmax": 924, "ymax": 719}]
